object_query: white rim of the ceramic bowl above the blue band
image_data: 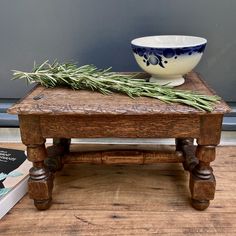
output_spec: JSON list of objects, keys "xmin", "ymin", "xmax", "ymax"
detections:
[{"xmin": 131, "ymin": 35, "xmax": 207, "ymax": 48}]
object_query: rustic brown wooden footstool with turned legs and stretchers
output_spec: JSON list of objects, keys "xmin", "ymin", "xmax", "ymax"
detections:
[{"xmin": 8, "ymin": 72, "xmax": 230, "ymax": 210}]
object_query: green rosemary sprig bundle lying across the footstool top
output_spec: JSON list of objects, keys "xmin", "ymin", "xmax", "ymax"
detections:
[{"xmin": 13, "ymin": 61, "xmax": 220, "ymax": 111}]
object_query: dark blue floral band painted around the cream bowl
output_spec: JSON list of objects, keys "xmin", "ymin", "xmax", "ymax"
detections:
[{"xmin": 132, "ymin": 43, "xmax": 206, "ymax": 68}]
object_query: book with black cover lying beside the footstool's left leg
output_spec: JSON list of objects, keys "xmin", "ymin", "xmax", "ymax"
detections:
[{"xmin": 0, "ymin": 148, "xmax": 32, "ymax": 219}]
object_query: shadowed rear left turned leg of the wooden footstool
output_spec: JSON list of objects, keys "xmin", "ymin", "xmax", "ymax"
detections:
[{"xmin": 45, "ymin": 138, "xmax": 71, "ymax": 172}]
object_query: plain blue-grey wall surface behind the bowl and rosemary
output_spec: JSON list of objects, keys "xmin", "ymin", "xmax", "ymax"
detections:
[{"xmin": 0, "ymin": 0, "xmax": 236, "ymax": 101}]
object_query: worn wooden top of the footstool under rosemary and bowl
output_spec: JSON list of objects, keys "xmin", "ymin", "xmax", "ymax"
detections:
[{"xmin": 8, "ymin": 72, "xmax": 230, "ymax": 115}]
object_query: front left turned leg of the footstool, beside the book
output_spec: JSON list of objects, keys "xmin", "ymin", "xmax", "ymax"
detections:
[{"xmin": 19, "ymin": 115, "xmax": 53, "ymax": 210}]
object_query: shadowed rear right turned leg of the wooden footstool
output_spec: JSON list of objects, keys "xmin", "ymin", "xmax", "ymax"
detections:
[{"xmin": 175, "ymin": 138, "xmax": 198, "ymax": 171}]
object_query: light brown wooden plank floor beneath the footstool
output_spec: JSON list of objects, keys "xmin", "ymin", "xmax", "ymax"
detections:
[{"xmin": 0, "ymin": 144, "xmax": 236, "ymax": 236}]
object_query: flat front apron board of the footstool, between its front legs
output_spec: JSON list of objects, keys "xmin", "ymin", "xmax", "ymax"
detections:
[{"xmin": 40, "ymin": 114, "xmax": 200, "ymax": 138}]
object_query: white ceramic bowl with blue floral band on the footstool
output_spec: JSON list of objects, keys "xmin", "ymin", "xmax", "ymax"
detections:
[{"xmin": 131, "ymin": 35, "xmax": 207, "ymax": 87}]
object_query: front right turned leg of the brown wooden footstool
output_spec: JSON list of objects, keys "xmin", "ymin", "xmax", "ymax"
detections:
[{"xmin": 189, "ymin": 114, "xmax": 223, "ymax": 210}]
